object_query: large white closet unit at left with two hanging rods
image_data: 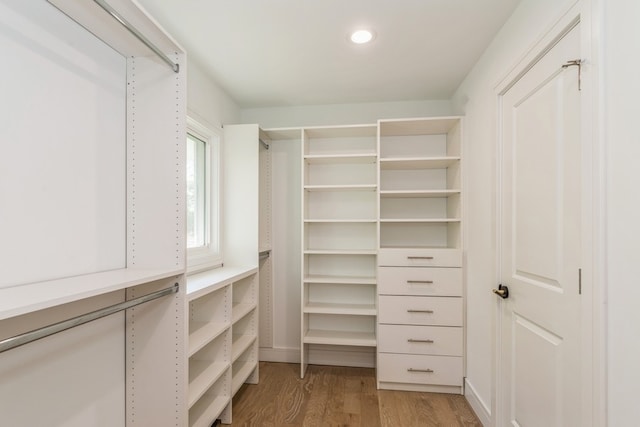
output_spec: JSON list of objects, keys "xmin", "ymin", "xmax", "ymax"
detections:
[{"xmin": 0, "ymin": 0, "xmax": 187, "ymax": 427}]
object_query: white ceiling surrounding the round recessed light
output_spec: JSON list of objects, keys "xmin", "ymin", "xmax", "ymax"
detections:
[{"xmin": 138, "ymin": 0, "xmax": 520, "ymax": 108}]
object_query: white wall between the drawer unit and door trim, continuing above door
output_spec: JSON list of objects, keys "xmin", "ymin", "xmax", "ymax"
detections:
[{"xmin": 452, "ymin": 0, "xmax": 574, "ymax": 424}]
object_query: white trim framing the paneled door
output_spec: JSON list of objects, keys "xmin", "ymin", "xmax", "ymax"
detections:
[{"xmin": 492, "ymin": 0, "xmax": 606, "ymax": 427}]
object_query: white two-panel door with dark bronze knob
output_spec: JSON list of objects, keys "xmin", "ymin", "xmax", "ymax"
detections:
[{"xmin": 496, "ymin": 21, "xmax": 581, "ymax": 427}]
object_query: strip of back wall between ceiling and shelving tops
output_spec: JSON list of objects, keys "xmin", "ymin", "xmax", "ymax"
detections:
[{"xmin": 242, "ymin": 100, "xmax": 451, "ymax": 128}]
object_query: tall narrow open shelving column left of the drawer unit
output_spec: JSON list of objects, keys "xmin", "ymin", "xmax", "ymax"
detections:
[{"xmin": 300, "ymin": 125, "xmax": 378, "ymax": 377}]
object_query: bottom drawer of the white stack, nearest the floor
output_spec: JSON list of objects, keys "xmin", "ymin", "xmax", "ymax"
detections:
[{"xmin": 377, "ymin": 353, "xmax": 462, "ymax": 386}]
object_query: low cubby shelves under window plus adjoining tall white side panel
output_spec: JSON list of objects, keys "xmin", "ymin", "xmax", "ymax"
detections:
[{"xmin": 187, "ymin": 125, "xmax": 262, "ymax": 427}]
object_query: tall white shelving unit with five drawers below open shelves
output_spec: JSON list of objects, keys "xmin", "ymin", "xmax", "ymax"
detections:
[{"xmin": 377, "ymin": 117, "xmax": 464, "ymax": 393}]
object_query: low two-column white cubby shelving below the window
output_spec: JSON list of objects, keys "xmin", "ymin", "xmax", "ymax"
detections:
[{"xmin": 187, "ymin": 267, "xmax": 258, "ymax": 427}]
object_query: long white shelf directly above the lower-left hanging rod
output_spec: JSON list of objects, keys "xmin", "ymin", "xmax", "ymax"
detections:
[{"xmin": 0, "ymin": 268, "xmax": 184, "ymax": 320}]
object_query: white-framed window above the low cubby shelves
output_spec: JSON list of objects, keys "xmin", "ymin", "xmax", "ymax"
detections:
[{"xmin": 186, "ymin": 118, "xmax": 222, "ymax": 272}]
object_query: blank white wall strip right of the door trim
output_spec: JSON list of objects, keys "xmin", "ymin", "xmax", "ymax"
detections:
[{"xmin": 599, "ymin": 0, "xmax": 640, "ymax": 427}]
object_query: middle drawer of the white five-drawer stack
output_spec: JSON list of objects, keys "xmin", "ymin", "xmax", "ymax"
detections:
[{"xmin": 378, "ymin": 295, "xmax": 462, "ymax": 326}]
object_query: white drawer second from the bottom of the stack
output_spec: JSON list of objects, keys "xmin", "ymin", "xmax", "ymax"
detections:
[{"xmin": 378, "ymin": 325, "xmax": 463, "ymax": 356}]
